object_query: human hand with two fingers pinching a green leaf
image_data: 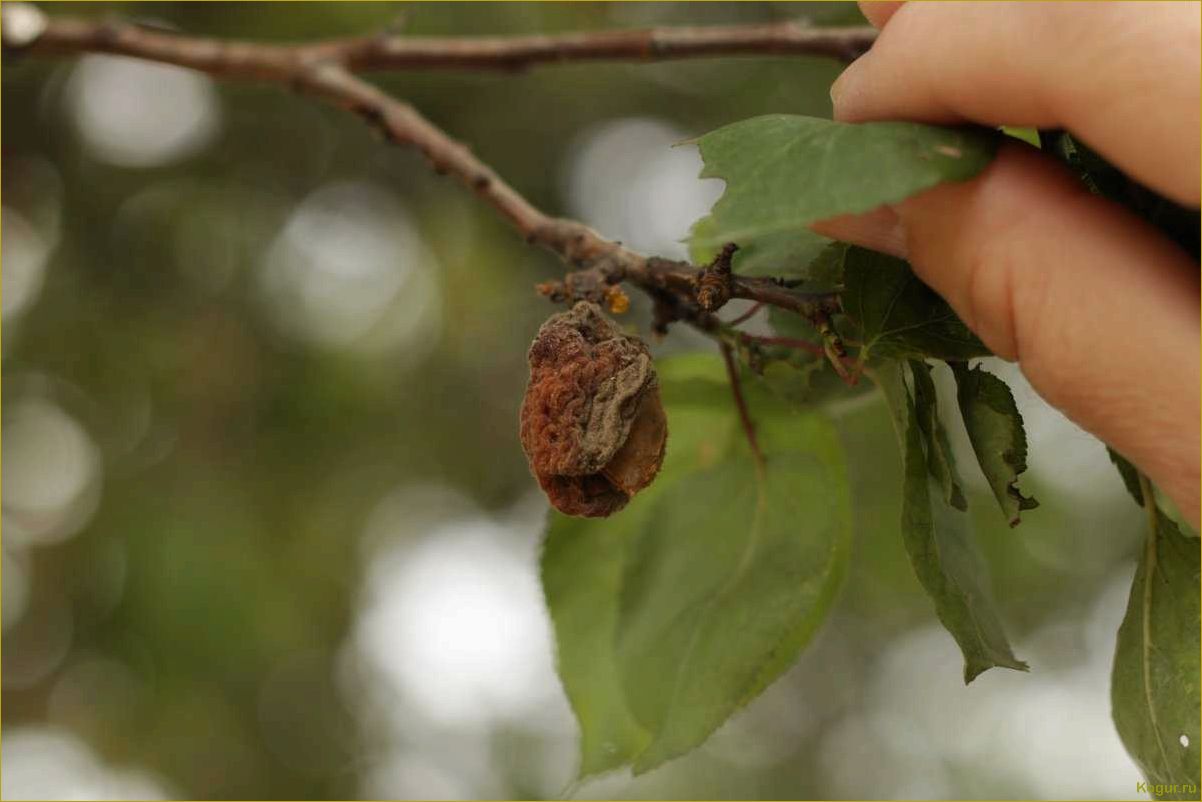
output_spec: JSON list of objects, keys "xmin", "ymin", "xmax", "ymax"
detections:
[{"xmin": 814, "ymin": 2, "xmax": 1202, "ymax": 527}]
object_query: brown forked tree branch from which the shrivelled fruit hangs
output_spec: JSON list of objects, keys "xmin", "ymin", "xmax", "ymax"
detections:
[{"xmin": 0, "ymin": 2, "xmax": 855, "ymax": 346}]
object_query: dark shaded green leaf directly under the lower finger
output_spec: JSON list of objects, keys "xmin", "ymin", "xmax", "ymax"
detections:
[{"xmin": 843, "ymin": 248, "xmax": 989, "ymax": 361}]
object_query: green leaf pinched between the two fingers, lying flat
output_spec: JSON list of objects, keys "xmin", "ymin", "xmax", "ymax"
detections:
[{"xmin": 694, "ymin": 114, "xmax": 1000, "ymax": 246}]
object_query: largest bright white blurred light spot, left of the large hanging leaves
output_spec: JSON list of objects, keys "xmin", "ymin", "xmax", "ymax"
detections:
[{"xmin": 356, "ymin": 495, "xmax": 558, "ymax": 726}]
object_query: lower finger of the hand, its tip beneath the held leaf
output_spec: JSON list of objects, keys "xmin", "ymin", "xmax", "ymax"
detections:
[{"xmin": 817, "ymin": 145, "xmax": 1202, "ymax": 525}]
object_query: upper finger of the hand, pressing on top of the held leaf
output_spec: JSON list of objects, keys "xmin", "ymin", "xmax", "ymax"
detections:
[{"xmin": 831, "ymin": 2, "xmax": 1202, "ymax": 206}]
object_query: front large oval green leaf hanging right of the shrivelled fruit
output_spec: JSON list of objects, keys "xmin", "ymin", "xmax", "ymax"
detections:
[{"xmin": 618, "ymin": 425, "xmax": 851, "ymax": 773}]
